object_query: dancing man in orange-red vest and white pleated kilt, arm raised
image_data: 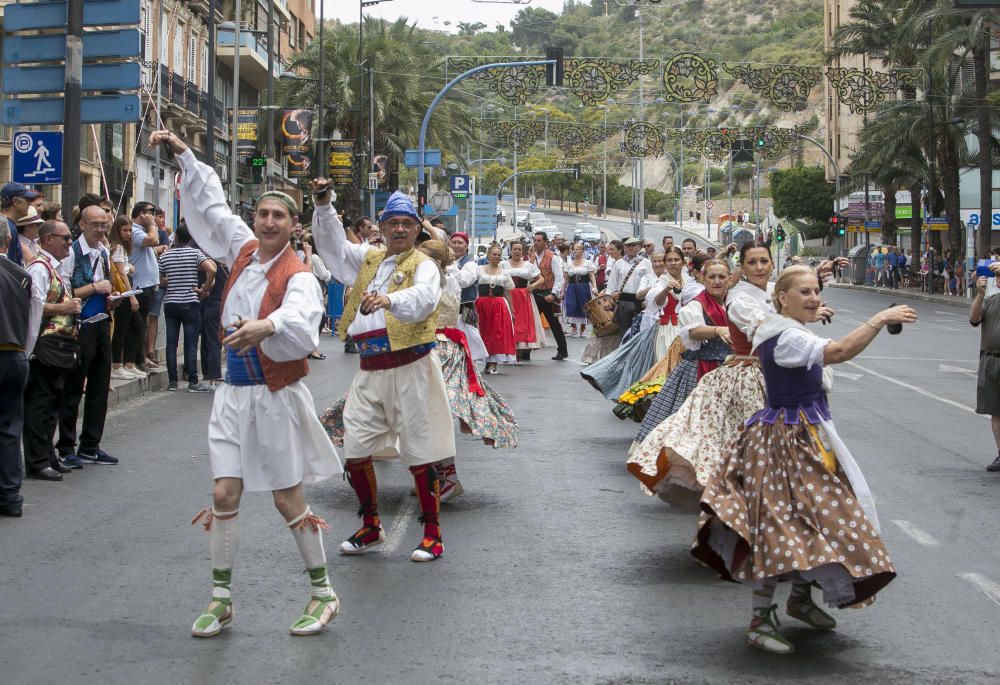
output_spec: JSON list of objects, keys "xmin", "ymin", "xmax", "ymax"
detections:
[{"xmin": 150, "ymin": 131, "xmax": 341, "ymax": 637}]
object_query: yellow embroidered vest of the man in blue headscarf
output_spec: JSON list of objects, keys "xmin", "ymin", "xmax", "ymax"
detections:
[{"xmin": 337, "ymin": 250, "xmax": 437, "ymax": 352}]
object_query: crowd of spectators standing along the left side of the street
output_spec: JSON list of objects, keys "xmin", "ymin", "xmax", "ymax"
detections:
[{"xmin": 0, "ymin": 183, "xmax": 229, "ymax": 517}]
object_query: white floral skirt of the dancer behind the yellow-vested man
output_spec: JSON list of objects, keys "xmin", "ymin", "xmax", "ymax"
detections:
[{"xmin": 319, "ymin": 339, "xmax": 519, "ymax": 448}]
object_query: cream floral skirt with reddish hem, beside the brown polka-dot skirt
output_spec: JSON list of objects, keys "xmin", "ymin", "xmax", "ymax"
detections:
[{"xmin": 628, "ymin": 363, "xmax": 765, "ymax": 501}]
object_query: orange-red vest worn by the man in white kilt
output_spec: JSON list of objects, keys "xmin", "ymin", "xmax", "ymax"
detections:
[{"xmin": 219, "ymin": 240, "xmax": 311, "ymax": 392}]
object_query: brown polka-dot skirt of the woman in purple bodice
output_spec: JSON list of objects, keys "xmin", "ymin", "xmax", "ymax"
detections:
[{"xmin": 691, "ymin": 415, "xmax": 896, "ymax": 607}]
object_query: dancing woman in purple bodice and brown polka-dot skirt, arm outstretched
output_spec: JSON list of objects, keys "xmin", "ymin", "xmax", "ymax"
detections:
[{"xmin": 691, "ymin": 266, "xmax": 917, "ymax": 654}]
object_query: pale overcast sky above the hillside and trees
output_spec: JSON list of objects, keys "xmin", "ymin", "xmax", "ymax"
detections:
[{"xmin": 324, "ymin": 0, "xmax": 563, "ymax": 32}]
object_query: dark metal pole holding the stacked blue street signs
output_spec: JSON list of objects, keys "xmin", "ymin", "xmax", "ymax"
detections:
[{"xmin": 62, "ymin": 0, "xmax": 83, "ymax": 208}]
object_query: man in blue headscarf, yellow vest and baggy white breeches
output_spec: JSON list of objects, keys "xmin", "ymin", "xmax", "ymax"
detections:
[{"xmin": 313, "ymin": 179, "xmax": 455, "ymax": 561}]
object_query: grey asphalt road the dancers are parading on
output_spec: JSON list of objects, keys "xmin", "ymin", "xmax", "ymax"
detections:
[{"xmin": 0, "ymin": 291, "xmax": 1000, "ymax": 685}]
